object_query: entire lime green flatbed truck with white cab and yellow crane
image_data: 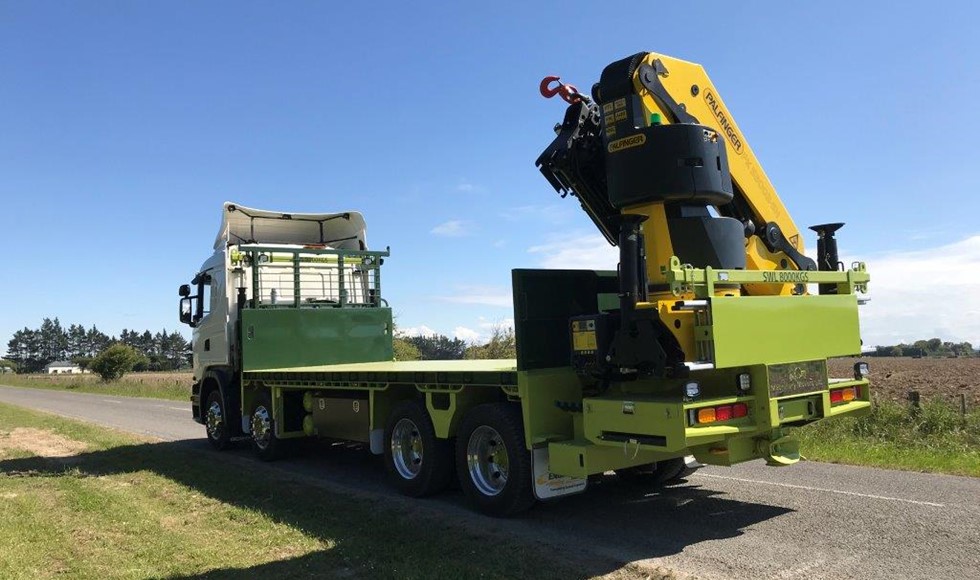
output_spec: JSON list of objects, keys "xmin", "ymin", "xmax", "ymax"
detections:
[{"xmin": 179, "ymin": 53, "xmax": 871, "ymax": 516}]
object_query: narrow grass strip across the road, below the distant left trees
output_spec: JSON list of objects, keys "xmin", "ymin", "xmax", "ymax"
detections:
[{"xmin": 0, "ymin": 373, "xmax": 193, "ymax": 401}]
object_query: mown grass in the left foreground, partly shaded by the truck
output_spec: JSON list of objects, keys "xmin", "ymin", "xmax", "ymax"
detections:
[{"xmin": 0, "ymin": 404, "xmax": 634, "ymax": 580}]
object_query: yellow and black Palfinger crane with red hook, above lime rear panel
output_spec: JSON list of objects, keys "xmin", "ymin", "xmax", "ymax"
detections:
[{"xmin": 536, "ymin": 52, "xmax": 824, "ymax": 295}]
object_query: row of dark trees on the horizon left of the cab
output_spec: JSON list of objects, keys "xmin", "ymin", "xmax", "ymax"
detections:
[{"xmin": 6, "ymin": 318, "xmax": 190, "ymax": 373}]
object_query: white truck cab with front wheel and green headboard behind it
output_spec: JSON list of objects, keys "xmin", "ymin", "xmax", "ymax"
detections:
[{"xmin": 179, "ymin": 202, "xmax": 391, "ymax": 447}]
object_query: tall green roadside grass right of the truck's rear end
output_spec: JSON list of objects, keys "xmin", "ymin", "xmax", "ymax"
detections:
[{"xmin": 797, "ymin": 400, "xmax": 980, "ymax": 477}]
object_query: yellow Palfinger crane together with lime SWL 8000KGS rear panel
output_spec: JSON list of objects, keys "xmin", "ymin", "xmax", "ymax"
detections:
[{"xmin": 536, "ymin": 52, "xmax": 867, "ymax": 386}]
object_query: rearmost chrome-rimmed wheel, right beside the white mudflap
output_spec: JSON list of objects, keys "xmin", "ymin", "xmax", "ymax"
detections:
[{"xmin": 456, "ymin": 403, "xmax": 535, "ymax": 517}]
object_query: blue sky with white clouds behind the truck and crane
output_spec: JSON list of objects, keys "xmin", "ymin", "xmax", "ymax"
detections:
[{"xmin": 0, "ymin": 1, "xmax": 980, "ymax": 351}]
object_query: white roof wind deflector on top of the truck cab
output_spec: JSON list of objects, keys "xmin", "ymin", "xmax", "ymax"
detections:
[{"xmin": 214, "ymin": 202, "xmax": 367, "ymax": 250}]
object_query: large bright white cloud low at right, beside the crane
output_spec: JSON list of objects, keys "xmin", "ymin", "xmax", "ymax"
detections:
[{"xmin": 845, "ymin": 235, "xmax": 980, "ymax": 345}]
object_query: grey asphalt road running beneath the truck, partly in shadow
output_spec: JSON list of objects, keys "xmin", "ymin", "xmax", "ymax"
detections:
[{"xmin": 0, "ymin": 387, "xmax": 980, "ymax": 579}]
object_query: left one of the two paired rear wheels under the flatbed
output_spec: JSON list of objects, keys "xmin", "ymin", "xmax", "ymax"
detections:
[{"xmin": 384, "ymin": 401, "xmax": 453, "ymax": 497}]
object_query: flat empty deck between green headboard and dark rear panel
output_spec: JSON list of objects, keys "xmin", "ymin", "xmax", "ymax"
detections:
[{"xmin": 243, "ymin": 359, "xmax": 517, "ymax": 387}]
